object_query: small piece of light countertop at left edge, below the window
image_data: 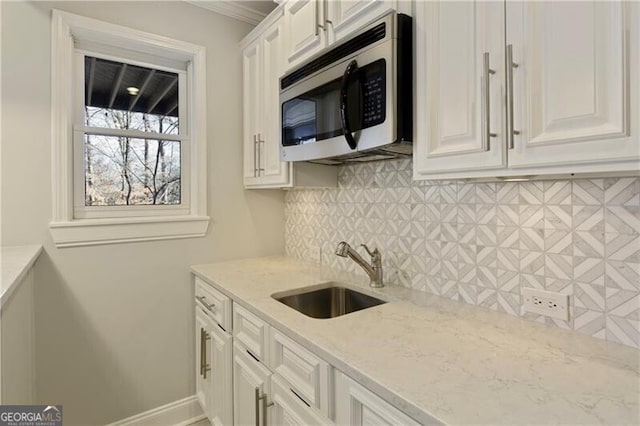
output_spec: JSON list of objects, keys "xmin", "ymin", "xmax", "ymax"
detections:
[{"xmin": 0, "ymin": 245, "xmax": 42, "ymax": 306}]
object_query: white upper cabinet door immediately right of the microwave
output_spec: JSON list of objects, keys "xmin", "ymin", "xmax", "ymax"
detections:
[{"xmin": 414, "ymin": 1, "xmax": 506, "ymax": 178}]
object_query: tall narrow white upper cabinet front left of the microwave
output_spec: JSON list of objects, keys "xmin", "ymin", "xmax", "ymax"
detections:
[{"xmin": 243, "ymin": 12, "xmax": 291, "ymax": 188}]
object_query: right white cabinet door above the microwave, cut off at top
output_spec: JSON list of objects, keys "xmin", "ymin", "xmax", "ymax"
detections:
[{"xmin": 325, "ymin": 0, "xmax": 397, "ymax": 43}]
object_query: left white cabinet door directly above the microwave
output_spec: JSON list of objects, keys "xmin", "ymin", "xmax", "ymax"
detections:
[{"xmin": 284, "ymin": 0, "xmax": 326, "ymax": 68}]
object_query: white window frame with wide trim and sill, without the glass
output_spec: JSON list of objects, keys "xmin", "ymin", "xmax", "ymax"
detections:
[{"xmin": 49, "ymin": 10, "xmax": 209, "ymax": 247}]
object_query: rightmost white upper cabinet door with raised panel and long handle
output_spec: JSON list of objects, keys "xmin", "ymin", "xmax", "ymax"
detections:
[{"xmin": 506, "ymin": 1, "xmax": 640, "ymax": 167}]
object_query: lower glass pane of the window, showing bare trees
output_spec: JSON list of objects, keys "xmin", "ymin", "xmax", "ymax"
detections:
[{"xmin": 84, "ymin": 134, "xmax": 181, "ymax": 206}]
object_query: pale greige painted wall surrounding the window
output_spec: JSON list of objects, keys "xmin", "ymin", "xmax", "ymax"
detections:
[{"xmin": 1, "ymin": 1, "xmax": 284, "ymax": 425}]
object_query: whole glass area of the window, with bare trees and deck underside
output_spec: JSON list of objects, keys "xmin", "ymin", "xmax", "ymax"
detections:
[{"xmin": 83, "ymin": 56, "xmax": 182, "ymax": 206}]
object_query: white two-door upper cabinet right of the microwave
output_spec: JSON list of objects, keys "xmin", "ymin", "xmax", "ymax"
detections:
[{"xmin": 414, "ymin": 1, "xmax": 640, "ymax": 179}]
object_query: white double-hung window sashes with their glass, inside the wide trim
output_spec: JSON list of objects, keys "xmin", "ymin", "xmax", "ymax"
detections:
[{"xmin": 74, "ymin": 50, "xmax": 189, "ymax": 218}]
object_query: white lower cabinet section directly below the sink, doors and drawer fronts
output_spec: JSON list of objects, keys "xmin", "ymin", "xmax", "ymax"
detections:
[{"xmin": 233, "ymin": 304, "xmax": 332, "ymax": 426}]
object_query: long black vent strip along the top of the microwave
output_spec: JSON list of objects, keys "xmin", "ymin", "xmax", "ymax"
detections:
[{"xmin": 280, "ymin": 22, "xmax": 386, "ymax": 90}]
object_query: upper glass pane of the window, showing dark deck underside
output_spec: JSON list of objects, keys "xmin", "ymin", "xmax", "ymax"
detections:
[{"xmin": 84, "ymin": 56, "xmax": 179, "ymax": 134}]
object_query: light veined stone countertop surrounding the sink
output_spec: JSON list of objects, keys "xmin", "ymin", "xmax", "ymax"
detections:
[{"xmin": 192, "ymin": 257, "xmax": 640, "ymax": 425}]
